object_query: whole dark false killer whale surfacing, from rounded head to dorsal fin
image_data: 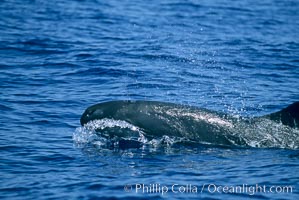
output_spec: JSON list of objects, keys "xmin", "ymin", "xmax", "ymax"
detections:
[{"xmin": 80, "ymin": 100, "xmax": 299, "ymax": 148}]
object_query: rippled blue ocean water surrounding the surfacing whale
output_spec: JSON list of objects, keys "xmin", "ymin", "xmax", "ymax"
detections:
[{"xmin": 0, "ymin": 0, "xmax": 299, "ymax": 200}]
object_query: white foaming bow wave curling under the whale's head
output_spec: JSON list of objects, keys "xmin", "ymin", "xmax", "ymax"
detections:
[{"xmin": 73, "ymin": 118, "xmax": 196, "ymax": 149}]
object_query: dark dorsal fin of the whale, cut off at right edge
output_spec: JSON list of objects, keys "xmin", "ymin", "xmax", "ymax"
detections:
[{"xmin": 266, "ymin": 101, "xmax": 299, "ymax": 128}]
